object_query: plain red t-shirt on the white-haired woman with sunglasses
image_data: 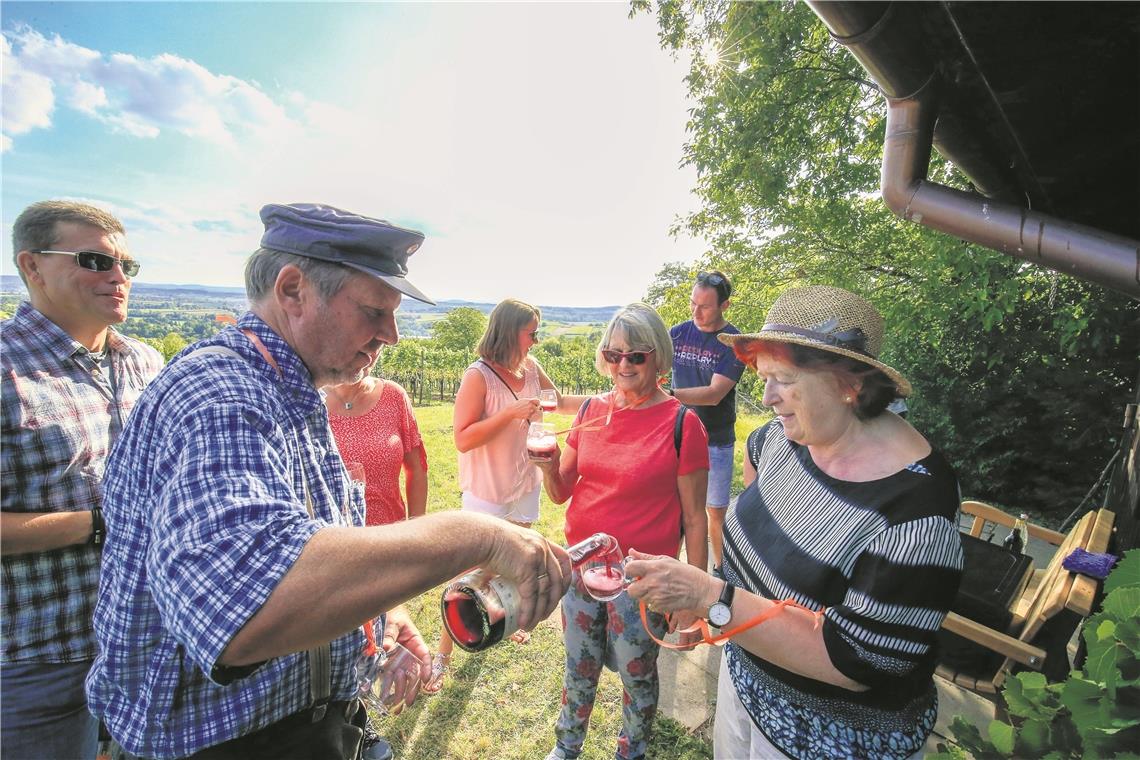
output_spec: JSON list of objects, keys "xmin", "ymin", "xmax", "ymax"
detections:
[{"xmin": 565, "ymin": 393, "xmax": 709, "ymax": 557}]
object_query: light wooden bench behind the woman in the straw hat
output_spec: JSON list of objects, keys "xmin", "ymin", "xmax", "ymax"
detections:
[{"xmin": 935, "ymin": 501, "xmax": 1115, "ymax": 696}]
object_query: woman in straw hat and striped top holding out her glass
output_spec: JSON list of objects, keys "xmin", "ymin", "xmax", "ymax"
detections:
[{"xmin": 627, "ymin": 286, "xmax": 962, "ymax": 758}]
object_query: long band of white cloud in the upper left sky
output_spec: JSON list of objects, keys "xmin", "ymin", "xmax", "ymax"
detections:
[{"xmin": 3, "ymin": 26, "xmax": 298, "ymax": 146}]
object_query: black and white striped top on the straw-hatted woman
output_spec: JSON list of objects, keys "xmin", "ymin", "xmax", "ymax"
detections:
[{"xmin": 724, "ymin": 420, "xmax": 962, "ymax": 757}]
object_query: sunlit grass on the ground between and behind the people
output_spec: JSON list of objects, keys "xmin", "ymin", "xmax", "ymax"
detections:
[{"xmin": 380, "ymin": 404, "xmax": 763, "ymax": 760}]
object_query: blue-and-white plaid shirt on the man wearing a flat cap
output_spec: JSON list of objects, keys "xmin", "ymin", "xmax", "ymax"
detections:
[{"xmin": 87, "ymin": 313, "xmax": 365, "ymax": 758}]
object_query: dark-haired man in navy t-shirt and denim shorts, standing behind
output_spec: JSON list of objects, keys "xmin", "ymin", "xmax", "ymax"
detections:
[{"xmin": 669, "ymin": 272, "xmax": 744, "ymax": 567}]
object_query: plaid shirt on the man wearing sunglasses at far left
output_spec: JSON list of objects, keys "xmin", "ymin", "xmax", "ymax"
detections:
[{"xmin": 0, "ymin": 302, "xmax": 162, "ymax": 662}]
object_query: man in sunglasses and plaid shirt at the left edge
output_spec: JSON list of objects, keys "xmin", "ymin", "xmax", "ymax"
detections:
[{"xmin": 0, "ymin": 201, "xmax": 162, "ymax": 758}]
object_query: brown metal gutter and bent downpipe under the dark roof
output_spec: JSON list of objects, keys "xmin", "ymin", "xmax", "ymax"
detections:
[{"xmin": 807, "ymin": 0, "xmax": 1140, "ymax": 300}]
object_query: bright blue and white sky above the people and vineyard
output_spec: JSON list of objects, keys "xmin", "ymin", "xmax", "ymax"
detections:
[{"xmin": 0, "ymin": 2, "xmax": 705, "ymax": 305}]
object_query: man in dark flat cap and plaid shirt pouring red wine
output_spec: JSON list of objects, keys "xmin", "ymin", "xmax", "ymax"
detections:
[{"xmin": 87, "ymin": 204, "xmax": 570, "ymax": 759}]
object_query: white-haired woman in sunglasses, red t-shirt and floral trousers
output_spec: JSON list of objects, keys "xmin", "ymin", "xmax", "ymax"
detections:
[{"xmin": 539, "ymin": 303, "xmax": 709, "ymax": 759}]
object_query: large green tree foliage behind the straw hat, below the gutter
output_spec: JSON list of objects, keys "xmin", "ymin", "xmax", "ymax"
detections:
[{"xmin": 632, "ymin": 0, "xmax": 1140, "ymax": 514}]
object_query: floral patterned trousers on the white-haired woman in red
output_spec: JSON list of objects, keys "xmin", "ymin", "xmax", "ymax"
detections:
[{"xmin": 554, "ymin": 571, "xmax": 668, "ymax": 760}]
